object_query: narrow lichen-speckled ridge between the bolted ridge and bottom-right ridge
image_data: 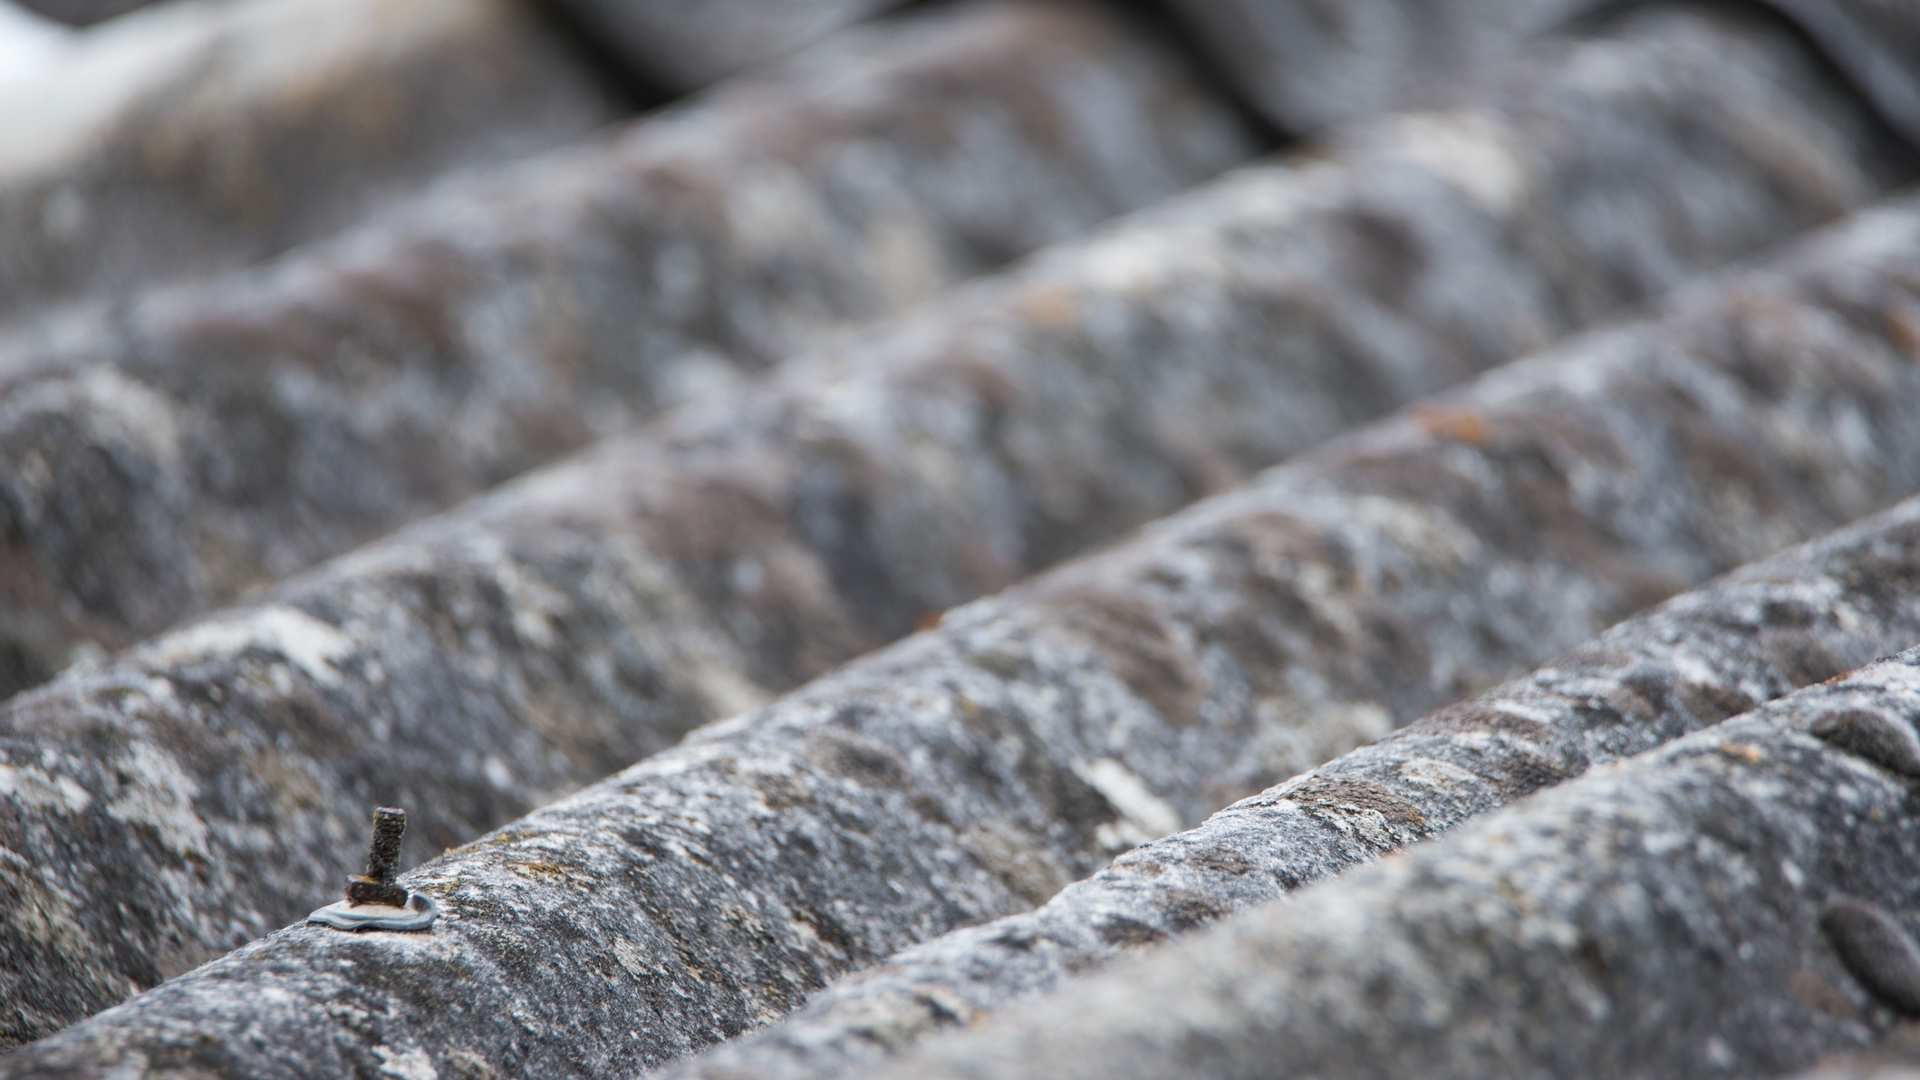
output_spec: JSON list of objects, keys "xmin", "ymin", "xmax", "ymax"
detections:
[{"xmin": 666, "ymin": 500, "xmax": 1920, "ymax": 1080}]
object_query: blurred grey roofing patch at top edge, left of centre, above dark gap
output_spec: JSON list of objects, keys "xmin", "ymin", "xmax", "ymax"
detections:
[{"xmin": 553, "ymin": 0, "xmax": 902, "ymax": 92}]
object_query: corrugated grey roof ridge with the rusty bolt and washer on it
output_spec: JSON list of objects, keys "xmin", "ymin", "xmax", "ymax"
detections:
[{"xmin": 18, "ymin": 94, "xmax": 1920, "ymax": 1076}]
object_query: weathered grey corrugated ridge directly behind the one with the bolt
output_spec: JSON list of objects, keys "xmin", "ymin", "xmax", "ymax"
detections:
[{"xmin": 0, "ymin": 2, "xmax": 1897, "ymax": 1038}]
